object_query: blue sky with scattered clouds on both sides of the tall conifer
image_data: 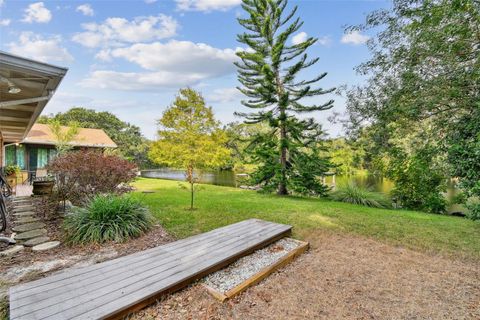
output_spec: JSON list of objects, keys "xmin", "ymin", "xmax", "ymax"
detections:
[{"xmin": 0, "ymin": 0, "xmax": 390, "ymax": 138}]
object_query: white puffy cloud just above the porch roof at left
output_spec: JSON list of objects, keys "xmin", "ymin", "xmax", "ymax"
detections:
[{"xmin": 7, "ymin": 32, "xmax": 73, "ymax": 62}]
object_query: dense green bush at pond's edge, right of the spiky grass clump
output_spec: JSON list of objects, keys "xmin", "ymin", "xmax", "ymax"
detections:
[{"xmin": 388, "ymin": 147, "xmax": 447, "ymax": 213}]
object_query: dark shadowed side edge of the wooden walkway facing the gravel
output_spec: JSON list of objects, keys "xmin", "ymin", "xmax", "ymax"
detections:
[{"xmin": 105, "ymin": 226, "xmax": 292, "ymax": 320}]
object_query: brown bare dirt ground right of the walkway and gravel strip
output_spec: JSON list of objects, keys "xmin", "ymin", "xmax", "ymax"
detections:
[{"xmin": 130, "ymin": 234, "xmax": 480, "ymax": 320}]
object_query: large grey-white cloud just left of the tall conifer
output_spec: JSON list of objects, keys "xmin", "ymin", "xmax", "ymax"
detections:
[{"xmin": 81, "ymin": 40, "xmax": 237, "ymax": 91}]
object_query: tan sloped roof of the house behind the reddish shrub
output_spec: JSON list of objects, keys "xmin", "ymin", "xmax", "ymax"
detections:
[{"xmin": 22, "ymin": 123, "xmax": 117, "ymax": 148}]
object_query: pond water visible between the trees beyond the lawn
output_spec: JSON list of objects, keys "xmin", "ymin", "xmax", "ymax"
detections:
[{"xmin": 141, "ymin": 168, "xmax": 462, "ymax": 211}]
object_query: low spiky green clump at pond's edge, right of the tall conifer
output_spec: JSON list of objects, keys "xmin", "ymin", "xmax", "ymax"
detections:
[{"xmin": 330, "ymin": 183, "xmax": 391, "ymax": 208}]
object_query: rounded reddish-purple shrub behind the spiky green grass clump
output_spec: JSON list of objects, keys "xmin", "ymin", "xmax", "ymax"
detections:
[{"xmin": 47, "ymin": 150, "xmax": 137, "ymax": 204}]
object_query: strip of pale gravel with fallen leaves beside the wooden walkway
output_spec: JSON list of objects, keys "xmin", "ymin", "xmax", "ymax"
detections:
[{"xmin": 204, "ymin": 238, "xmax": 301, "ymax": 293}]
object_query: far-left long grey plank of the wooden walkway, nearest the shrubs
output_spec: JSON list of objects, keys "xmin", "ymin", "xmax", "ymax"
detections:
[{"xmin": 10, "ymin": 219, "xmax": 252, "ymax": 297}]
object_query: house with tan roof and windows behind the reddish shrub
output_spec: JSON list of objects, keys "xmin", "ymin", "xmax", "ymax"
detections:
[{"xmin": 5, "ymin": 123, "xmax": 117, "ymax": 172}]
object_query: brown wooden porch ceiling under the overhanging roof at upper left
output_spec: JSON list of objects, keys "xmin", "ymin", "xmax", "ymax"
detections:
[{"xmin": 0, "ymin": 51, "xmax": 67, "ymax": 142}]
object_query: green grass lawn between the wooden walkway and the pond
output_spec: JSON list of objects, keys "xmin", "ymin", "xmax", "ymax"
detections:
[{"xmin": 134, "ymin": 178, "xmax": 480, "ymax": 259}]
